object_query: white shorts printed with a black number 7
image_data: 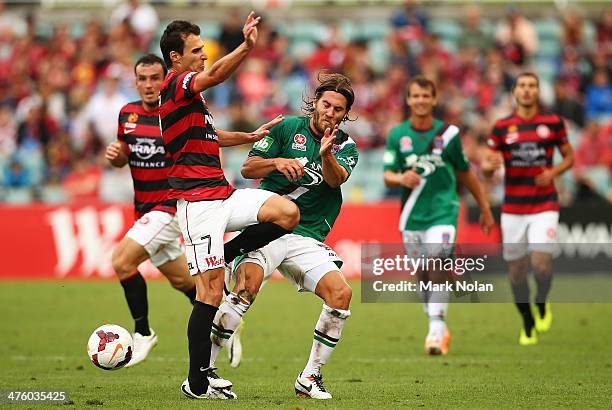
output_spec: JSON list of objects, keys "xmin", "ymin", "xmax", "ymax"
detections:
[{"xmin": 176, "ymin": 188, "xmax": 275, "ymax": 275}]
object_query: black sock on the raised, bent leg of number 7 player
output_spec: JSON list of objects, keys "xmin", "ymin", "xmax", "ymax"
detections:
[{"xmin": 223, "ymin": 222, "xmax": 292, "ymax": 263}]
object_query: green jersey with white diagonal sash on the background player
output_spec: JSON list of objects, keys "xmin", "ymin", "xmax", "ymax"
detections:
[{"xmin": 384, "ymin": 119, "xmax": 470, "ymax": 231}]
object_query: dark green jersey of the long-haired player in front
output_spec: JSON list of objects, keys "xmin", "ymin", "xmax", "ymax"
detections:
[{"xmin": 249, "ymin": 117, "xmax": 359, "ymax": 241}]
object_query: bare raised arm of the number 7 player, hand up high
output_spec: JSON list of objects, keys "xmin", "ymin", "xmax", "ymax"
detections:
[{"xmin": 193, "ymin": 12, "xmax": 261, "ymax": 93}]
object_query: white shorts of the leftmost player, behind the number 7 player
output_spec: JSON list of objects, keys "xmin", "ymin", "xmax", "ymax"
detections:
[{"xmin": 125, "ymin": 211, "xmax": 183, "ymax": 266}]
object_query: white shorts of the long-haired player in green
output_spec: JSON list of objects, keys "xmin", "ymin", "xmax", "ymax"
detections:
[{"xmin": 234, "ymin": 234, "xmax": 342, "ymax": 293}]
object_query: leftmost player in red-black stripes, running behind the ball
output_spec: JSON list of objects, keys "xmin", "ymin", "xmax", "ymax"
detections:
[{"xmin": 106, "ymin": 54, "xmax": 196, "ymax": 367}]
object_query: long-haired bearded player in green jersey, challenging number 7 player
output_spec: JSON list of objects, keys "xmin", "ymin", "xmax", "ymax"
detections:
[{"xmin": 210, "ymin": 73, "xmax": 359, "ymax": 399}]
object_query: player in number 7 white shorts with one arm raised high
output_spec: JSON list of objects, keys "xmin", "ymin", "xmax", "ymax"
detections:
[{"xmin": 159, "ymin": 16, "xmax": 299, "ymax": 399}]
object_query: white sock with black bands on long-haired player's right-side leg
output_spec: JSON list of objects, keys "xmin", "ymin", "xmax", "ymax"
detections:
[{"xmin": 302, "ymin": 304, "xmax": 351, "ymax": 376}]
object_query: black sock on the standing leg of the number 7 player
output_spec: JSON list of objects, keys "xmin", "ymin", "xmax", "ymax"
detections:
[{"xmin": 187, "ymin": 300, "xmax": 218, "ymax": 395}]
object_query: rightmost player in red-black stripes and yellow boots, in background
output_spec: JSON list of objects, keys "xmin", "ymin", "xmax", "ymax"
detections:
[{"xmin": 483, "ymin": 72, "xmax": 574, "ymax": 345}]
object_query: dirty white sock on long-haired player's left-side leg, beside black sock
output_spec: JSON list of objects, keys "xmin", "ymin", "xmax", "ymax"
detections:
[{"xmin": 210, "ymin": 293, "xmax": 251, "ymax": 367}]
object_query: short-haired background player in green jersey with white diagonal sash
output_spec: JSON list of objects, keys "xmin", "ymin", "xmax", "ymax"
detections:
[{"xmin": 384, "ymin": 76, "xmax": 494, "ymax": 355}]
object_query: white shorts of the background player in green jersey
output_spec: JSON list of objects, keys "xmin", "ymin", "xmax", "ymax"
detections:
[{"xmin": 402, "ymin": 225, "xmax": 457, "ymax": 258}]
